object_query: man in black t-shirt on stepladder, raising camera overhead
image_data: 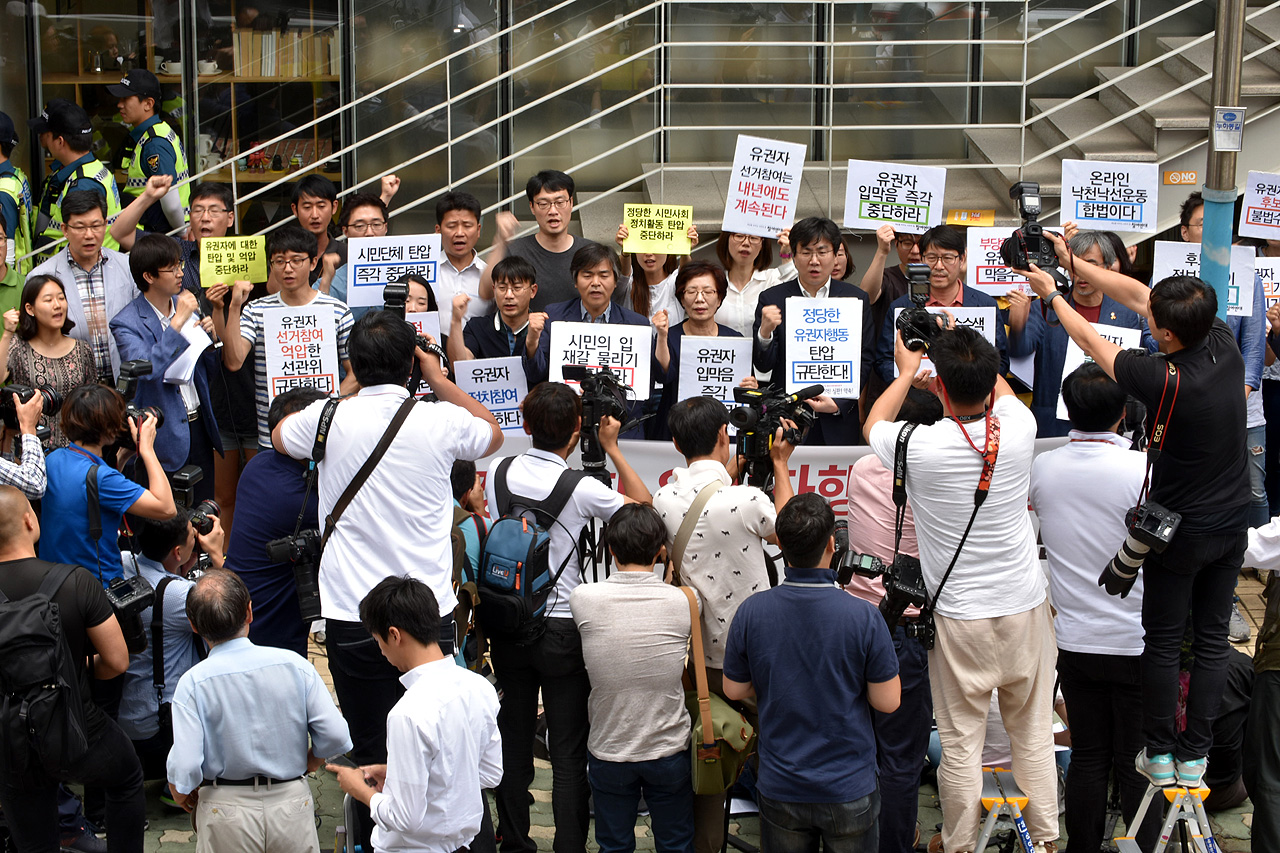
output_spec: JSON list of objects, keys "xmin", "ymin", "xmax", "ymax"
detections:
[{"xmin": 1027, "ymin": 236, "xmax": 1251, "ymax": 788}]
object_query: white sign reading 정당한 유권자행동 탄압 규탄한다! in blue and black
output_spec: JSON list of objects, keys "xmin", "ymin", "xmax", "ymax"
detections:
[{"xmin": 783, "ymin": 296, "xmax": 863, "ymax": 397}]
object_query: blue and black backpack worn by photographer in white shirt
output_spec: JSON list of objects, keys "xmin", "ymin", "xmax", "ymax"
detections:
[{"xmin": 475, "ymin": 457, "xmax": 586, "ymax": 643}]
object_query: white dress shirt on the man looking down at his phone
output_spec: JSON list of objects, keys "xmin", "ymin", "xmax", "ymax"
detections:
[{"xmin": 369, "ymin": 657, "xmax": 502, "ymax": 853}]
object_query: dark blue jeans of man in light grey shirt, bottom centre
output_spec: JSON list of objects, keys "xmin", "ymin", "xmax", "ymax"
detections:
[{"xmin": 586, "ymin": 749, "xmax": 694, "ymax": 853}]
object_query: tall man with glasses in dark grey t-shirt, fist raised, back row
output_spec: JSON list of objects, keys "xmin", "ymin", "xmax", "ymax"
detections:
[{"xmin": 480, "ymin": 169, "xmax": 590, "ymax": 311}]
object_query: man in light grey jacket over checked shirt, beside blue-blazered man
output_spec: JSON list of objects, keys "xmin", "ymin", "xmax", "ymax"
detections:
[{"xmin": 27, "ymin": 190, "xmax": 138, "ymax": 384}]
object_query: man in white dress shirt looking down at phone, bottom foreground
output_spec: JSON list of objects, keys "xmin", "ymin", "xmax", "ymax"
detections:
[{"xmin": 328, "ymin": 576, "xmax": 502, "ymax": 853}]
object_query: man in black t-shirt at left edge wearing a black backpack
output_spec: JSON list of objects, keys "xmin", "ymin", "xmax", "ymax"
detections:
[{"xmin": 0, "ymin": 485, "xmax": 146, "ymax": 853}]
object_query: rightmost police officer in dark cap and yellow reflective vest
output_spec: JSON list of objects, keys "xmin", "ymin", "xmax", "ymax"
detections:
[{"xmin": 106, "ymin": 68, "xmax": 191, "ymax": 233}]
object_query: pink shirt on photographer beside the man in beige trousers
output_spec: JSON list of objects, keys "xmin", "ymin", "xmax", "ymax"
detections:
[{"xmin": 845, "ymin": 453, "xmax": 920, "ymax": 616}]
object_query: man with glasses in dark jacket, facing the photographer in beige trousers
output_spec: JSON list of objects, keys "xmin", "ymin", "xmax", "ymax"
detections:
[{"xmin": 876, "ymin": 225, "xmax": 1009, "ymax": 384}]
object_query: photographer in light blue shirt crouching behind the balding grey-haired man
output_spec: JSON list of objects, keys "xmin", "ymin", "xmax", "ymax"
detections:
[{"xmin": 119, "ymin": 508, "xmax": 223, "ymax": 779}]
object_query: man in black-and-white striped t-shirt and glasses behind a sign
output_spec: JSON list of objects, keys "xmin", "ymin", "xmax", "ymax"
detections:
[{"xmin": 209, "ymin": 225, "xmax": 356, "ymax": 447}]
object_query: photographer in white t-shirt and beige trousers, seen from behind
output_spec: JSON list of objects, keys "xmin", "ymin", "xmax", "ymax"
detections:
[{"xmin": 865, "ymin": 322, "xmax": 1057, "ymax": 852}]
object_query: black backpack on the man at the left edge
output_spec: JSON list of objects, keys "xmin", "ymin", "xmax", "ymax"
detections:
[{"xmin": 0, "ymin": 564, "xmax": 88, "ymax": 779}]
